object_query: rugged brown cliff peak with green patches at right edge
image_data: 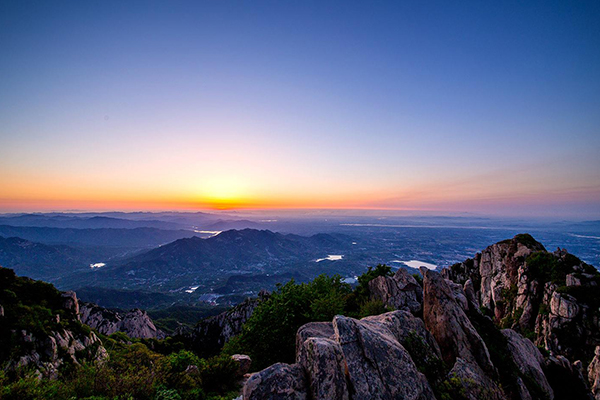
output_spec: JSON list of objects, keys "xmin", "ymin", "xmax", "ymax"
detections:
[{"xmin": 442, "ymin": 234, "xmax": 600, "ymax": 366}]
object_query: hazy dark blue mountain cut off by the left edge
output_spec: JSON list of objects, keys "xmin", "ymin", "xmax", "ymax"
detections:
[{"xmin": 0, "ymin": 237, "xmax": 93, "ymax": 280}]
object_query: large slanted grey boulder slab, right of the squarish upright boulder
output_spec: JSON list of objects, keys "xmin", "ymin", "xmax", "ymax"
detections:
[{"xmin": 333, "ymin": 315, "xmax": 434, "ymax": 399}]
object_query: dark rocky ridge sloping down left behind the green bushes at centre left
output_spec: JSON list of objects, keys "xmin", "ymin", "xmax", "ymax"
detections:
[{"xmin": 183, "ymin": 291, "xmax": 269, "ymax": 357}]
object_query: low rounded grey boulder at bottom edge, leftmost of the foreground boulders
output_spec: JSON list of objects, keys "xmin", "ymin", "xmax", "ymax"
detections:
[{"xmin": 242, "ymin": 363, "xmax": 308, "ymax": 400}]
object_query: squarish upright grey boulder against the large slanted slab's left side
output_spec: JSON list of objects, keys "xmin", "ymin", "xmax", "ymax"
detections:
[{"xmin": 296, "ymin": 337, "xmax": 350, "ymax": 400}]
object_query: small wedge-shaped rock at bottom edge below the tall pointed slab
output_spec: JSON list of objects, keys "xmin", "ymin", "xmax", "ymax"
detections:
[{"xmin": 448, "ymin": 358, "xmax": 506, "ymax": 400}]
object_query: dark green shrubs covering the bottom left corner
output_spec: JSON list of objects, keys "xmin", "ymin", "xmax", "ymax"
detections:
[{"xmin": 0, "ymin": 343, "xmax": 237, "ymax": 400}]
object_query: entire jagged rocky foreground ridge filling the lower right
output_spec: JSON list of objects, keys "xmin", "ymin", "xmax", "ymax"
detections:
[{"xmin": 243, "ymin": 235, "xmax": 600, "ymax": 400}]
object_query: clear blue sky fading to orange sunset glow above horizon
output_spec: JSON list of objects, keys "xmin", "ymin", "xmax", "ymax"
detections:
[{"xmin": 0, "ymin": 0, "xmax": 600, "ymax": 218}]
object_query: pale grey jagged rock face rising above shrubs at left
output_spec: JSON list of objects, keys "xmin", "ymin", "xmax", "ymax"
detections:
[{"xmin": 78, "ymin": 302, "xmax": 165, "ymax": 339}]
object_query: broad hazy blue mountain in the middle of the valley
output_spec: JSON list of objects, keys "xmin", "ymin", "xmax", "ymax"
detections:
[{"xmin": 70, "ymin": 229, "xmax": 351, "ymax": 291}]
